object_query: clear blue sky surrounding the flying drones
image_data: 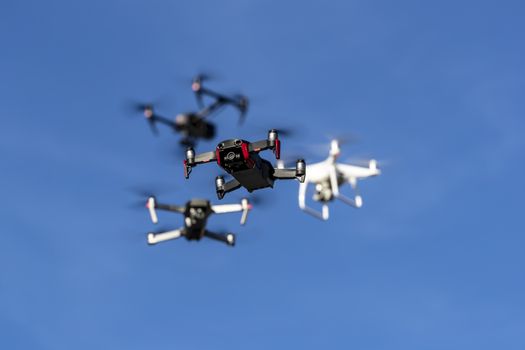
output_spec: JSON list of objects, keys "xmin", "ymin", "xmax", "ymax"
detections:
[{"xmin": 0, "ymin": 0, "xmax": 525, "ymax": 350}]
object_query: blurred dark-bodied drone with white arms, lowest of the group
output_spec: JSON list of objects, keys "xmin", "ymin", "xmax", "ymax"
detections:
[{"xmin": 146, "ymin": 196, "xmax": 252, "ymax": 247}]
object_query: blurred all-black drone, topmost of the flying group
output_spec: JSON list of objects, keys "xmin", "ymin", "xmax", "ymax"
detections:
[{"xmin": 136, "ymin": 75, "xmax": 249, "ymax": 146}]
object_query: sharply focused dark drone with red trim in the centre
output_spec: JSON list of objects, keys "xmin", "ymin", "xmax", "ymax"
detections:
[{"xmin": 184, "ymin": 129, "xmax": 306, "ymax": 199}]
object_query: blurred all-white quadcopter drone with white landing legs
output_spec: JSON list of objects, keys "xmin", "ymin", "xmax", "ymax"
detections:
[{"xmin": 292, "ymin": 140, "xmax": 381, "ymax": 220}]
